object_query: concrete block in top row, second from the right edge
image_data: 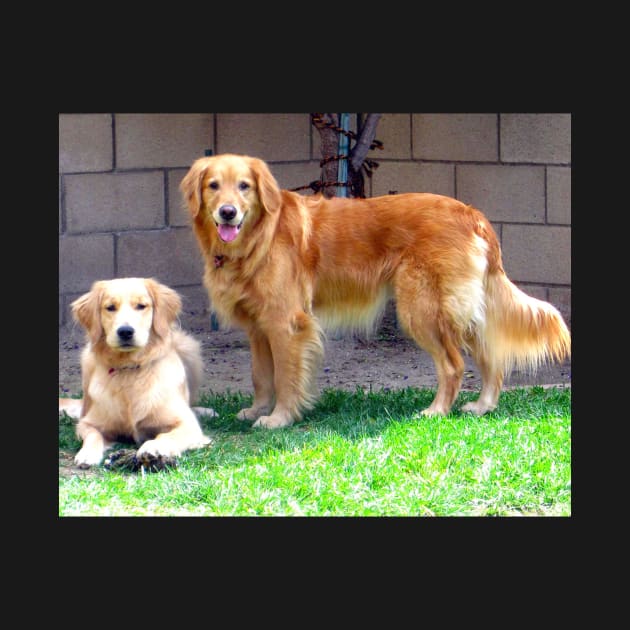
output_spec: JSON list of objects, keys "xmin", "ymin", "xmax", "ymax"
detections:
[{"xmin": 411, "ymin": 114, "xmax": 499, "ymax": 162}]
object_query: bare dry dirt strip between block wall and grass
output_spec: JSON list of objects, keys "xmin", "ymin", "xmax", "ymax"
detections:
[{"xmin": 59, "ymin": 308, "xmax": 571, "ymax": 396}]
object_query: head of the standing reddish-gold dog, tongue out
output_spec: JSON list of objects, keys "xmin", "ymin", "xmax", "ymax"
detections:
[{"xmin": 180, "ymin": 154, "xmax": 281, "ymax": 243}]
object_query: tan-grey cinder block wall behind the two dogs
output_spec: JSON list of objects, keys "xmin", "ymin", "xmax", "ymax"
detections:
[{"xmin": 59, "ymin": 113, "xmax": 571, "ymax": 325}]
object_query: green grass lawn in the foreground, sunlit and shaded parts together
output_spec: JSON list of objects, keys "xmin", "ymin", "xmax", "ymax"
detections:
[{"xmin": 59, "ymin": 387, "xmax": 571, "ymax": 516}]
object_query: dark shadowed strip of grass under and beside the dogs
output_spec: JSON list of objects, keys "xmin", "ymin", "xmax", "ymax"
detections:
[{"xmin": 59, "ymin": 387, "xmax": 571, "ymax": 478}]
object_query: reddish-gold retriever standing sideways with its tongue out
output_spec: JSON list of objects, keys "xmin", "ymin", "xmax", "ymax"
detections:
[{"xmin": 180, "ymin": 154, "xmax": 571, "ymax": 428}]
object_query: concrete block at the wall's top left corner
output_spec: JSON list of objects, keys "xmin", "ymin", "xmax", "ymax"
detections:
[{"xmin": 59, "ymin": 114, "xmax": 114, "ymax": 173}]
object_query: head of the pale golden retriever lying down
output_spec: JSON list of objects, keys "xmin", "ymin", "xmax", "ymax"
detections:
[{"xmin": 71, "ymin": 278, "xmax": 181, "ymax": 352}]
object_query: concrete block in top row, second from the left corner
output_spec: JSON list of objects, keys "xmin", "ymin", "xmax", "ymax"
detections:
[{"xmin": 114, "ymin": 114, "xmax": 214, "ymax": 169}]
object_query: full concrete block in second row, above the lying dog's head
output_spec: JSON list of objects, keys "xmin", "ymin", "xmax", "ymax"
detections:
[{"xmin": 64, "ymin": 171, "xmax": 165, "ymax": 233}]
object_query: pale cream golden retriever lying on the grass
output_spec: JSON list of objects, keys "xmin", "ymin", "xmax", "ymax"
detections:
[{"xmin": 59, "ymin": 278, "xmax": 214, "ymax": 468}]
